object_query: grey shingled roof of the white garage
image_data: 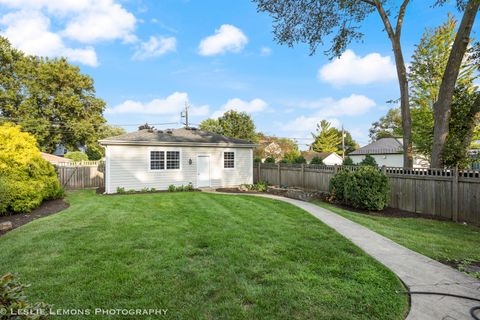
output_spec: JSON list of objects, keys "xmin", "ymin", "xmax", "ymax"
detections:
[{"xmin": 99, "ymin": 128, "xmax": 256, "ymax": 148}]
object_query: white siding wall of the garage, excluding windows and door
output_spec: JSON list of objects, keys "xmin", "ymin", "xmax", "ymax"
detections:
[{"xmin": 105, "ymin": 145, "xmax": 253, "ymax": 193}]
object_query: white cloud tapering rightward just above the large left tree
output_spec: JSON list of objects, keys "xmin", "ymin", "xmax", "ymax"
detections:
[{"xmin": 0, "ymin": 11, "xmax": 98, "ymax": 66}]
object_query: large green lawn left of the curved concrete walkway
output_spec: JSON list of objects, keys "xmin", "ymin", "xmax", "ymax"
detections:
[{"xmin": 0, "ymin": 191, "xmax": 408, "ymax": 319}]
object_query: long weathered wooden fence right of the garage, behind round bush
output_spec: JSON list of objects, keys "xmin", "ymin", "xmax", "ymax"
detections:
[{"xmin": 253, "ymin": 164, "xmax": 480, "ymax": 225}]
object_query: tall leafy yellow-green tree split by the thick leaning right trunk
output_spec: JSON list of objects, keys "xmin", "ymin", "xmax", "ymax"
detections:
[{"xmin": 409, "ymin": 16, "xmax": 476, "ymax": 166}]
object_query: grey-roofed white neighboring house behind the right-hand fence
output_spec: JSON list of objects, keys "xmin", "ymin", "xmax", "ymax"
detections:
[{"xmin": 348, "ymin": 138, "xmax": 429, "ymax": 168}]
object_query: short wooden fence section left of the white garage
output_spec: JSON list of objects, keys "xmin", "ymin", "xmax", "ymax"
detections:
[{"xmin": 55, "ymin": 161, "xmax": 105, "ymax": 190}]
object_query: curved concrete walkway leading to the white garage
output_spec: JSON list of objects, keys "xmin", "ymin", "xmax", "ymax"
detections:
[{"xmin": 217, "ymin": 191, "xmax": 480, "ymax": 320}]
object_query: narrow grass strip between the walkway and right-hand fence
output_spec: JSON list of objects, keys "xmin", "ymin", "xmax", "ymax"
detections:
[{"xmin": 315, "ymin": 201, "xmax": 480, "ymax": 276}]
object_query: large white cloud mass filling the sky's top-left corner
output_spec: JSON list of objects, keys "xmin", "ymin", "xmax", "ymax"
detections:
[{"xmin": 0, "ymin": 0, "xmax": 137, "ymax": 66}]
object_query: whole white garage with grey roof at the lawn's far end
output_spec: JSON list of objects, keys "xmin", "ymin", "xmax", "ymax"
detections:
[{"xmin": 100, "ymin": 128, "xmax": 256, "ymax": 193}]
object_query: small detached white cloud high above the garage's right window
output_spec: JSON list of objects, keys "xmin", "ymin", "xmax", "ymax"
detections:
[{"xmin": 198, "ymin": 24, "xmax": 248, "ymax": 56}]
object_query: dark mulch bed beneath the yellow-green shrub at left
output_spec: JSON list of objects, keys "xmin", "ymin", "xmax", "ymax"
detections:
[{"xmin": 0, "ymin": 199, "xmax": 70, "ymax": 236}]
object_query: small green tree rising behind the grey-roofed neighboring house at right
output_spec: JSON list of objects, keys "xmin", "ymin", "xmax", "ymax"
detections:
[{"xmin": 368, "ymin": 108, "xmax": 403, "ymax": 141}]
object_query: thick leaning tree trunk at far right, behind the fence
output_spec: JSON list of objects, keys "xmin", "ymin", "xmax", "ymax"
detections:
[{"xmin": 430, "ymin": 0, "xmax": 480, "ymax": 168}]
